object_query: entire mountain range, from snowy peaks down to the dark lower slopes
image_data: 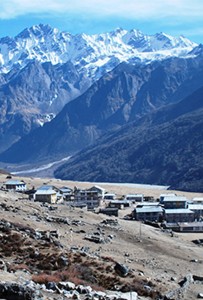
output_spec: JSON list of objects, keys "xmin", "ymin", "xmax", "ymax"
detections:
[{"xmin": 0, "ymin": 24, "xmax": 203, "ymax": 189}]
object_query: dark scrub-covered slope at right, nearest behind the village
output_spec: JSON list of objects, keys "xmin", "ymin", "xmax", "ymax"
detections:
[{"xmin": 55, "ymin": 84, "xmax": 203, "ymax": 192}]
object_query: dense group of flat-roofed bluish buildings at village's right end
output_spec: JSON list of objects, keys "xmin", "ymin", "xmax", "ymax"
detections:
[{"xmin": 132, "ymin": 194, "xmax": 203, "ymax": 232}]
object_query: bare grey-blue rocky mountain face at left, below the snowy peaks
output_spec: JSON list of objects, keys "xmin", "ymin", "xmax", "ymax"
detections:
[{"xmin": 0, "ymin": 61, "xmax": 90, "ymax": 151}]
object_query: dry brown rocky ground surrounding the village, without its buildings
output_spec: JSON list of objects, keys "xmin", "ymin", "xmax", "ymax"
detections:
[{"xmin": 0, "ymin": 175, "xmax": 203, "ymax": 300}]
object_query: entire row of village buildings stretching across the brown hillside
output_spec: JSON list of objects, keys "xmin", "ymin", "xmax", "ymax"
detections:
[{"xmin": 1, "ymin": 179, "xmax": 203, "ymax": 231}]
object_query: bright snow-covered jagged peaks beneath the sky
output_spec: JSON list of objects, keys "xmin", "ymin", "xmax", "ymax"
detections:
[{"xmin": 0, "ymin": 24, "xmax": 197, "ymax": 79}]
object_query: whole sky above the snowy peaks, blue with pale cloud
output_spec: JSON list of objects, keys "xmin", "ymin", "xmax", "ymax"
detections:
[{"xmin": 0, "ymin": 0, "xmax": 203, "ymax": 43}]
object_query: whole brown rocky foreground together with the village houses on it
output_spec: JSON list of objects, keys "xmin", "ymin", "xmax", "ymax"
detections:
[{"xmin": 0, "ymin": 173, "xmax": 203, "ymax": 300}]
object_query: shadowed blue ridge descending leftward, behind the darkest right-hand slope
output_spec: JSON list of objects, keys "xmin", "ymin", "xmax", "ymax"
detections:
[{"xmin": 0, "ymin": 54, "xmax": 203, "ymax": 162}]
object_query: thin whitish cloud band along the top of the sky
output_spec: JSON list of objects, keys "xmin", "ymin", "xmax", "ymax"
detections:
[{"xmin": 0, "ymin": 0, "xmax": 203, "ymax": 20}]
